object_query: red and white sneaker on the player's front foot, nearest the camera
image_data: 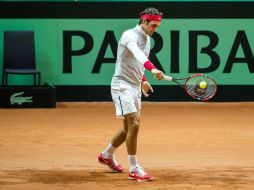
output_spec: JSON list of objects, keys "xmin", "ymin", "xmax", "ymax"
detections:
[{"xmin": 128, "ymin": 166, "xmax": 154, "ymax": 181}]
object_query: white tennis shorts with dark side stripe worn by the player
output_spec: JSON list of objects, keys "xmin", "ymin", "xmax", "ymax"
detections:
[{"xmin": 111, "ymin": 82, "xmax": 141, "ymax": 118}]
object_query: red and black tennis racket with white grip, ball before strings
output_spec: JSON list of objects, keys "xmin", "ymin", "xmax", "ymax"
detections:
[{"xmin": 163, "ymin": 74, "xmax": 217, "ymax": 101}]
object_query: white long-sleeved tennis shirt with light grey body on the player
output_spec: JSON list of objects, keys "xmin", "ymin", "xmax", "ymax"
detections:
[{"xmin": 112, "ymin": 25, "xmax": 150, "ymax": 87}]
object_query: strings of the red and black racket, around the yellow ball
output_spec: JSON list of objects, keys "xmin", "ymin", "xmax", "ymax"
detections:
[{"xmin": 185, "ymin": 75, "xmax": 217, "ymax": 100}]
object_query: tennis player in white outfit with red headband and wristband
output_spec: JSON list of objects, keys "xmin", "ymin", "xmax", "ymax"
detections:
[{"xmin": 98, "ymin": 8, "xmax": 164, "ymax": 181}]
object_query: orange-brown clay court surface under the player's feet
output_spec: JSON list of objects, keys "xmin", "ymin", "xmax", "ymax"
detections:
[{"xmin": 0, "ymin": 102, "xmax": 254, "ymax": 190}]
